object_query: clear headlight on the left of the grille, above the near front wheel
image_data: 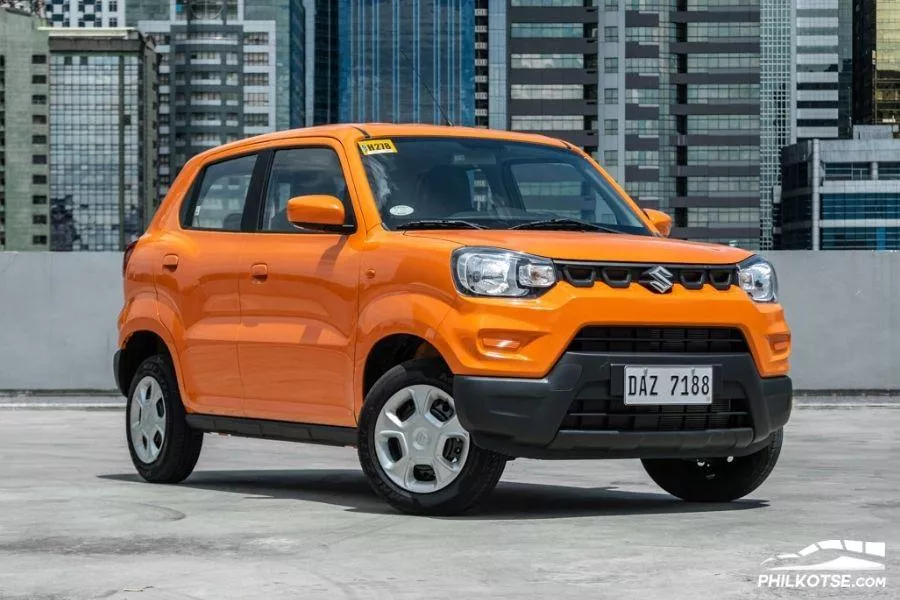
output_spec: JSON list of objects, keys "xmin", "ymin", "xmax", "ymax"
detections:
[{"xmin": 451, "ymin": 248, "xmax": 556, "ymax": 298}]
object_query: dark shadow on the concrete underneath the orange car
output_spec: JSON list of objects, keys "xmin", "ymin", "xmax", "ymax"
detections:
[{"xmin": 98, "ymin": 469, "xmax": 768, "ymax": 520}]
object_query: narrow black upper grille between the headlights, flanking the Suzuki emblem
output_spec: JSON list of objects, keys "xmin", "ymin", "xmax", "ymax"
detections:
[{"xmin": 556, "ymin": 261, "xmax": 738, "ymax": 291}]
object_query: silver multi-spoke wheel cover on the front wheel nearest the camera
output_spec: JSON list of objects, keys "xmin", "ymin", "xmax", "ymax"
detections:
[{"xmin": 375, "ymin": 384, "xmax": 470, "ymax": 494}]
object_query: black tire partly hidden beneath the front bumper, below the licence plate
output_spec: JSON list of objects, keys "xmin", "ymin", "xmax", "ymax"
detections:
[{"xmin": 641, "ymin": 429, "xmax": 784, "ymax": 502}]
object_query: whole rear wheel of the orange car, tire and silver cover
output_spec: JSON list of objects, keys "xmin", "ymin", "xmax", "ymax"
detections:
[{"xmin": 125, "ymin": 355, "xmax": 203, "ymax": 483}]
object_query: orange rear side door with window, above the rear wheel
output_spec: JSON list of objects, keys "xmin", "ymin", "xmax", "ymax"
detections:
[{"xmin": 156, "ymin": 154, "xmax": 257, "ymax": 415}]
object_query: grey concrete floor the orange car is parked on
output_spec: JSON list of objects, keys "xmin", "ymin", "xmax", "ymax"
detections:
[{"xmin": 0, "ymin": 406, "xmax": 900, "ymax": 600}]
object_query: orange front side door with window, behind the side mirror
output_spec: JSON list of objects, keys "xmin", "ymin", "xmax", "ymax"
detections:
[{"xmin": 238, "ymin": 138, "xmax": 360, "ymax": 425}]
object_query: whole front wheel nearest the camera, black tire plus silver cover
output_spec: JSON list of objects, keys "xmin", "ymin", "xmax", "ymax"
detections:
[{"xmin": 357, "ymin": 359, "xmax": 506, "ymax": 515}]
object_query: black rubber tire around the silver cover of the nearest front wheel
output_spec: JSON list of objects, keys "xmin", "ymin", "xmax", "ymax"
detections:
[{"xmin": 357, "ymin": 358, "xmax": 506, "ymax": 516}]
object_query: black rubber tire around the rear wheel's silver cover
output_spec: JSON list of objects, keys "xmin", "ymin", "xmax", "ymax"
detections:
[{"xmin": 125, "ymin": 354, "xmax": 203, "ymax": 483}]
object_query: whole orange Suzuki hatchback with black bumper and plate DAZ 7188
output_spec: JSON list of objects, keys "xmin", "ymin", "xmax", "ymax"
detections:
[{"xmin": 115, "ymin": 124, "xmax": 792, "ymax": 514}]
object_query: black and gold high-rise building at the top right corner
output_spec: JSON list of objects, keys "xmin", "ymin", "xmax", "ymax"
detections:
[{"xmin": 853, "ymin": 0, "xmax": 900, "ymax": 125}]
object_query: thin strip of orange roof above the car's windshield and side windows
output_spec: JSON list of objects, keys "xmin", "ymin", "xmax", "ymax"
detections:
[{"xmin": 195, "ymin": 123, "xmax": 572, "ymax": 161}]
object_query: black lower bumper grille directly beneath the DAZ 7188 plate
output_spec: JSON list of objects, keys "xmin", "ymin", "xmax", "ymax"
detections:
[{"xmin": 560, "ymin": 394, "xmax": 752, "ymax": 432}]
